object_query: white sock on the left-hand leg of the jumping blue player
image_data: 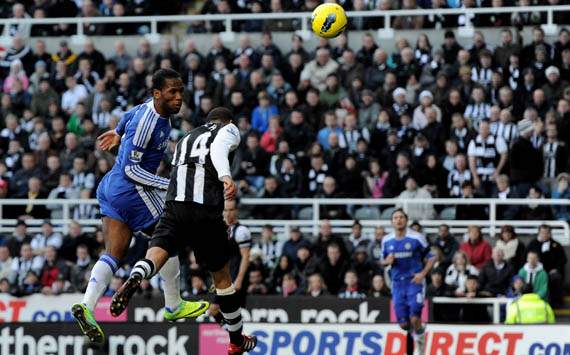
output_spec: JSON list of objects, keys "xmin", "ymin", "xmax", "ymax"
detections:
[{"xmin": 82, "ymin": 254, "xmax": 118, "ymax": 310}]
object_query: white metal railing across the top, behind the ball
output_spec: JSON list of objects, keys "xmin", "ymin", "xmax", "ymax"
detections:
[{"xmin": 0, "ymin": 5, "xmax": 570, "ymax": 38}]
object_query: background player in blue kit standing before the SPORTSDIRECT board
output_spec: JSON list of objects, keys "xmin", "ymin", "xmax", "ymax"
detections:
[{"xmin": 382, "ymin": 208, "xmax": 435, "ymax": 355}]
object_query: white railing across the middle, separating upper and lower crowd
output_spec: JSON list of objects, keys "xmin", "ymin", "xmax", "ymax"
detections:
[{"xmin": 0, "ymin": 198, "xmax": 570, "ymax": 246}]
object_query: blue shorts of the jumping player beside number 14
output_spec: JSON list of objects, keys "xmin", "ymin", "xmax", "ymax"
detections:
[{"xmin": 97, "ymin": 173, "xmax": 164, "ymax": 232}]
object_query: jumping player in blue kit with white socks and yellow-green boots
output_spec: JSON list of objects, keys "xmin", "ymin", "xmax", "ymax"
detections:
[{"xmin": 71, "ymin": 69, "xmax": 209, "ymax": 343}]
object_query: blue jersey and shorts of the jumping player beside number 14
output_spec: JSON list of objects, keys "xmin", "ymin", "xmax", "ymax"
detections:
[{"xmin": 97, "ymin": 100, "xmax": 171, "ymax": 231}]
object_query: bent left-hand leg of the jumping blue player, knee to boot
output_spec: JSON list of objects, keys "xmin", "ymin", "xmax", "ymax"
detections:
[{"xmin": 71, "ymin": 217, "xmax": 132, "ymax": 343}]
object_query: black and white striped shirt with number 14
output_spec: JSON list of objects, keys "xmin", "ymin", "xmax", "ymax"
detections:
[{"xmin": 166, "ymin": 122, "xmax": 240, "ymax": 206}]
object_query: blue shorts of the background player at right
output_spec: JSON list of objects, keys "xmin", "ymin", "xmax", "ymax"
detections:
[{"xmin": 392, "ymin": 279, "xmax": 424, "ymax": 324}]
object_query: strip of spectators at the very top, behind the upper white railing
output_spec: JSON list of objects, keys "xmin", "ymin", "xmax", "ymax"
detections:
[{"xmin": 0, "ymin": 0, "xmax": 570, "ymax": 37}]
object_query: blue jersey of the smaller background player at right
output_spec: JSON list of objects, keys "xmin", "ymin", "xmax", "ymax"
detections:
[{"xmin": 382, "ymin": 229, "xmax": 431, "ymax": 281}]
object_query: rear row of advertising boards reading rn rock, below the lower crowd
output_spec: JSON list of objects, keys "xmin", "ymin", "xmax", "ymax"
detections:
[{"xmin": 0, "ymin": 294, "xmax": 540, "ymax": 324}]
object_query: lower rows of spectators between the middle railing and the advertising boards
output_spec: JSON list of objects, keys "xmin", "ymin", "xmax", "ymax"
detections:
[{"xmin": 0, "ymin": 216, "xmax": 567, "ymax": 322}]
